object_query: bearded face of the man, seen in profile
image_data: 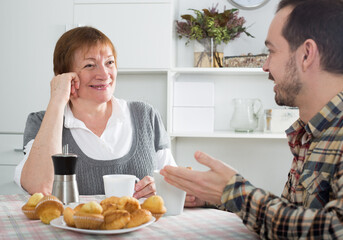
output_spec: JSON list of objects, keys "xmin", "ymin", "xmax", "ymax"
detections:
[{"xmin": 263, "ymin": 7, "xmax": 302, "ymax": 107}]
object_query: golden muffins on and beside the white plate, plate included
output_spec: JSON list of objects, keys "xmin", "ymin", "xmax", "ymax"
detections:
[{"xmin": 22, "ymin": 193, "xmax": 167, "ymax": 234}]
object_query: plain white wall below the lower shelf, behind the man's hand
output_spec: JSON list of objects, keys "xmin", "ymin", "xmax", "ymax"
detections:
[{"xmin": 174, "ymin": 138, "xmax": 292, "ymax": 195}]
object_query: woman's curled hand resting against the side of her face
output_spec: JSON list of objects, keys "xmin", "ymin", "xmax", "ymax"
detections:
[{"xmin": 50, "ymin": 72, "xmax": 80, "ymax": 104}]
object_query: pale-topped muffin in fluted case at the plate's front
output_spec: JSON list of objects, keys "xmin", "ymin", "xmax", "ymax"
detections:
[{"xmin": 74, "ymin": 201, "xmax": 104, "ymax": 230}]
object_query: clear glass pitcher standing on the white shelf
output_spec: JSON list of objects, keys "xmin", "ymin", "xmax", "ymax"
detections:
[{"xmin": 230, "ymin": 98, "xmax": 262, "ymax": 132}]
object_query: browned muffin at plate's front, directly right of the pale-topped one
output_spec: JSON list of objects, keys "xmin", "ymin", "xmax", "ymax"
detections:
[{"xmin": 101, "ymin": 210, "xmax": 130, "ymax": 230}]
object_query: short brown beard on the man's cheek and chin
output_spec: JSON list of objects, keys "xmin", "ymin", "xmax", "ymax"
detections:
[{"xmin": 275, "ymin": 55, "xmax": 302, "ymax": 107}]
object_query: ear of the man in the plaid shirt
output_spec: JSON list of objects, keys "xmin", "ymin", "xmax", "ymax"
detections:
[{"xmin": 301, "ymin": 39, "xmax": 319, "ymax": 71}]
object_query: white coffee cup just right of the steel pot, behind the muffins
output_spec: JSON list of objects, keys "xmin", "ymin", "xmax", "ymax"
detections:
[{"xmin": 103, "ymin": 174, "xmax": 139, "ymax": 198}]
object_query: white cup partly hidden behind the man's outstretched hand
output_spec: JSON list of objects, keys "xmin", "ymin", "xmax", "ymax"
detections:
[{"xmin": 154, "ymin": 170, "xmax": 186, "ymax": 216}]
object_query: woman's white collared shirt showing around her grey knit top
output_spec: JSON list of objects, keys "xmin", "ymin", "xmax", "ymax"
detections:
[{"xmin": 14, "ymin": 97, "xmax": 176, "ymax": 187}]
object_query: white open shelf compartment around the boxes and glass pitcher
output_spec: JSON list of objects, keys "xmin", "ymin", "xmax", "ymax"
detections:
[{"xmin": 167, "ymin": 68, "xmax": 286, "ymax": 139}]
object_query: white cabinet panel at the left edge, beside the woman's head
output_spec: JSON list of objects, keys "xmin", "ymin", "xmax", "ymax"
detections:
[{"xmin": 0, "ymin": 0, "xmax": 73, "ymax": 132}]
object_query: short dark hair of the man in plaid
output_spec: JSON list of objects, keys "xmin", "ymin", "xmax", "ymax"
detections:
[{"xmin": 277, "ymin": 0, "xmax": 343, "ymax": 74}]
